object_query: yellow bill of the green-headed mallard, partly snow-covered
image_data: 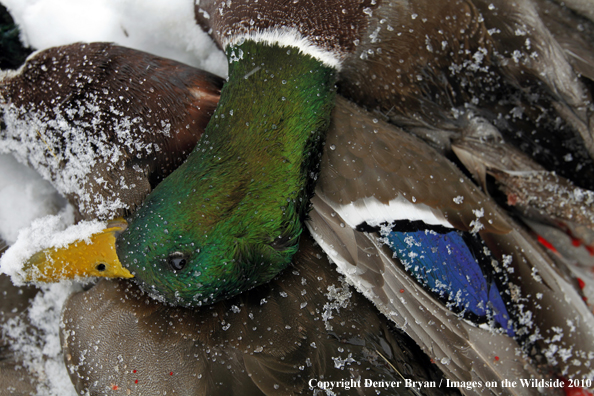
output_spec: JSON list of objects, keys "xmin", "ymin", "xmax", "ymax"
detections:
[{"xmin": 22, "ymin": 219, "xmax": 134, "ymax": 282}]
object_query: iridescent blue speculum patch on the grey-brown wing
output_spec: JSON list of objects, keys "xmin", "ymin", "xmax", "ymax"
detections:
[{"xmin": 384, "ymin": 230, "xmax": 515, "ymax": 337}]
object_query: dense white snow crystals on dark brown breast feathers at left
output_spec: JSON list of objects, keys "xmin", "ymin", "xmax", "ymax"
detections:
[{"xmin": 0, "ymin": 97, "xmax": 160, "ymax": 219}]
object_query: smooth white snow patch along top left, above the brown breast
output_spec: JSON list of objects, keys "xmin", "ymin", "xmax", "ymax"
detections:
[{"xmin": 2, "ymin": 0, "xmax": 227, "ymax": 75}]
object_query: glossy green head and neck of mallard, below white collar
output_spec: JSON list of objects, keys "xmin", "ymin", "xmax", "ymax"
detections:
[{"xmin": 117, "ymin": 41, "xmax": 335, "ymax": 305}]
